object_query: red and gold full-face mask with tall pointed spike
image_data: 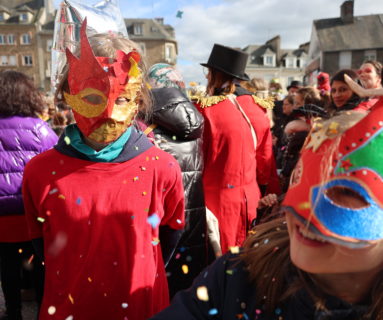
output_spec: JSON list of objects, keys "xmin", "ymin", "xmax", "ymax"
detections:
[{"xmin": 64, "ymin": 19, "xmax": 142, "ymax": 143}]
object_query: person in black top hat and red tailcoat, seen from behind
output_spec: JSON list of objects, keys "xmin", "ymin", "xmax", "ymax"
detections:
[{"xmin": 196, "ymin": 44, "xmax": 273, "ymax": 254}]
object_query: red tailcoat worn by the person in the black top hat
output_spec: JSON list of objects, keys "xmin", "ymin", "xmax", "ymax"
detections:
[{"xmin": 197, "ymin": 95, "xmax": 274, "ymax": 253}]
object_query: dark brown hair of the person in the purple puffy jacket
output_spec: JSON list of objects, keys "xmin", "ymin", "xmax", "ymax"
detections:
[{"xmin": 0, "ymin": 70, "xmax": 44, "ymax": 117}]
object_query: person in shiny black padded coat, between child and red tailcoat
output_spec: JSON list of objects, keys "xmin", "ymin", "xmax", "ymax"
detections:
[{"xmin": 146, "ymin": 64, "xmax": 215, "ymax": 296}]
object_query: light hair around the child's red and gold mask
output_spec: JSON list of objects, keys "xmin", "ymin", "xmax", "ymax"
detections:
[{"xmin": 55, "ymin": 33, "xmax": 152, "ymax": 118}]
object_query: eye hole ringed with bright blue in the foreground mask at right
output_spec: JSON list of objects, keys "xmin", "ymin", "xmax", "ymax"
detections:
[{"xmin": 325, "ymin": 186, "xmax": 370, "ymax": 209}]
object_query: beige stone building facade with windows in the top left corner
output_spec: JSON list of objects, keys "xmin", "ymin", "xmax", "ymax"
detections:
[{"xmin": 0, "ymin": 0, "xmax": 54, "ymax": 91}]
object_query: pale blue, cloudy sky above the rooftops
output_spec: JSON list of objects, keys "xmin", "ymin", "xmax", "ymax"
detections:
[{"xmin": 55, "ymin": 0, "xmax": 383, "ymax": 82}]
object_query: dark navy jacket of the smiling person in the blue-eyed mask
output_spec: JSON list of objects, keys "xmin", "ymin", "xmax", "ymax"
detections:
[{"xmin": 151, "ymin": 254, "xmax": 367, "ymax": 320}]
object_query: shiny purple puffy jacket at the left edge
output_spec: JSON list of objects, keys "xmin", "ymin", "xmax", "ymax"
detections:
[{"xmin": 0, "ymin": 116, "xmax": 57, "ymax": 216}]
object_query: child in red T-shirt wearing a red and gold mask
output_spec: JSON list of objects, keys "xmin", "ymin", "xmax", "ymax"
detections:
[{"xmin": 23, "ymin": 21, "xmax": 184, "ymax": 320}]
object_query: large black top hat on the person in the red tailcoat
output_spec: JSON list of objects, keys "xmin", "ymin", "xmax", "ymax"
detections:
[{"xmin": 201, "ymin": 44, "xmax": 250, "ymax": 81}]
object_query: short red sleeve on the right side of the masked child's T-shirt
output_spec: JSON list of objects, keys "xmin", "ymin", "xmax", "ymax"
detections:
[{"xmin": 161, "ymin": 159, "xmax": 185, "ymax": 230}]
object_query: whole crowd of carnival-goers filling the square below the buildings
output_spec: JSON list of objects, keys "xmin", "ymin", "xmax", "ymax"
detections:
[{"xmin": 0, "ymin": 14, "xmax": 383, "ymax": 320}]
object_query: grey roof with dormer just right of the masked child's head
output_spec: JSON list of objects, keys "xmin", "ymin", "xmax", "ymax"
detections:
[{"xmin": 124, "ymin": 19, "xmax": 175, "ymax": 41}]
